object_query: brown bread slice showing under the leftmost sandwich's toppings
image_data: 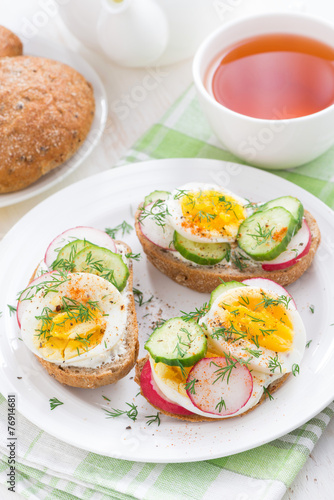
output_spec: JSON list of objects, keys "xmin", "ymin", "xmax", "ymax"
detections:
[{"xmin": 28, "ymin": 241, "xmax": 139, "ymax": 389}]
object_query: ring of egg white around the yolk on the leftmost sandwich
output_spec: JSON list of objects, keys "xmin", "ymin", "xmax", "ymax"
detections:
[{"xmin": 21, "ymin": 273, "xmax": 128, "ymax": 368}]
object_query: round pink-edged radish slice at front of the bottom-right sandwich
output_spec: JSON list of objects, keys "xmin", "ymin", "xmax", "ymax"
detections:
[{"xmin": 187, "ymin": 357, "xmax": 253, "ymax": 417}]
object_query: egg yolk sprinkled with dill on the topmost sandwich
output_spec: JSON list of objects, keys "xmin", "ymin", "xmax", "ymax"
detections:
[{"xmin": 180, "ymin": 190, "xmax": 247, "ymax": 237}]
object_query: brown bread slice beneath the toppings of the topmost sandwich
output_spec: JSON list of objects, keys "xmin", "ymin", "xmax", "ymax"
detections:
[{"xmin": 135, "ymin": 210, "xmax": 321, "ymax": 293}]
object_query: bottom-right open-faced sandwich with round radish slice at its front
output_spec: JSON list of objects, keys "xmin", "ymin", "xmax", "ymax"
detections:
[{"xmin": 135, "ymin": 278, "xmax": 306, "ymax": 421}]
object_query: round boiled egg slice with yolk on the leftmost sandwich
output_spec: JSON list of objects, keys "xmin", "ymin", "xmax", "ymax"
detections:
[{"xmin": 21, "ymin": 273, "xmax": 127, "ymax": 368}]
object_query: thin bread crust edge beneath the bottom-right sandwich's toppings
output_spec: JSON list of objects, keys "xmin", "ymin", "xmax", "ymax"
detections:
[{"xmin": 134, "ymin": 355, "xmax": 290, "ymax": 422}]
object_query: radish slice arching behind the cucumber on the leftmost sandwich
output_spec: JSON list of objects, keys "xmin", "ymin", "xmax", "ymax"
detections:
[{"xmin": 44, "ymin": 226, "xmax": 117, "ymax": 269}]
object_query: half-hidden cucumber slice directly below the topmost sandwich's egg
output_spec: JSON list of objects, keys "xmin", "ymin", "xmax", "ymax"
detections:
[{"xmin": 173, "ymin": 231, "xmax": 230, "ymax": 266}]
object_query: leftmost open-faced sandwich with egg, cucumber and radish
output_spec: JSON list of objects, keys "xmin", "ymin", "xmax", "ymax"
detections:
[{"xmin": 17, "ymin": 227, "xmax": 138, "ymax": 388}]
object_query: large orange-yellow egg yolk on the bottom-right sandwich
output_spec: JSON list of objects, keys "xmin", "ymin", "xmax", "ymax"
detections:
[{"xmin": 215, "ymin": 291, "xmax": 293, "ymax": 352}]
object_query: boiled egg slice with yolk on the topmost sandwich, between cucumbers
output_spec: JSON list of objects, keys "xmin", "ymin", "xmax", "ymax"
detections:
[{"xmin": 166, "ymin": 183, "xmax": 249, "ymax": 243}]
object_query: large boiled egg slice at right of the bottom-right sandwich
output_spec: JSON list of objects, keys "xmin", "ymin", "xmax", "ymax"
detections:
[{"xmin": 203, "ymin": 286, "xmax": 306, "ymax": 375}]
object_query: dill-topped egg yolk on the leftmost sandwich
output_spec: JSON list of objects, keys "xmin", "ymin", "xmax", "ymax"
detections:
[{"xmin": 34, "ymin": 298, "xmax": 105, "ymax": 361}]
